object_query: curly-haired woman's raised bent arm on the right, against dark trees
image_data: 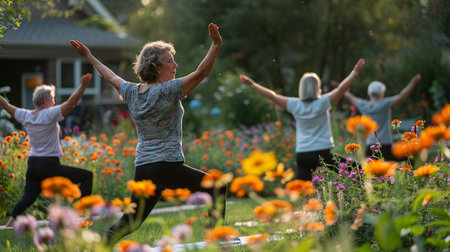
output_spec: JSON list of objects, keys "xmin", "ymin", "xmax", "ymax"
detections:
[{"xmin": 183, "ymin": 23, "xmax": 222, "ymax": 95}]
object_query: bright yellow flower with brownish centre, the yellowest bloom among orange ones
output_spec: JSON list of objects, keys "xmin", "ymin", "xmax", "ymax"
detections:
[{"xmin": 242, "ymin": 150, "xmax": 277, "ymax": 176}]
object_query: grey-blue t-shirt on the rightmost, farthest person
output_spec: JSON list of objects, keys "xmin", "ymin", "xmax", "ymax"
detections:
[{"xmin": 356, "ymin": 97, "xmax": 393, "ymax": 145}]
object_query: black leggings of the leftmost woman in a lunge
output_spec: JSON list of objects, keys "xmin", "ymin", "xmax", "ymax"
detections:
[{"xmin": 11, "ymin": 157, "xmax": 93, "ymax": 218}]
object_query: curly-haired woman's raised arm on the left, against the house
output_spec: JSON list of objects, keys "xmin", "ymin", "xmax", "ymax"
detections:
[{"xmin": 70, "ymin": 40, "xmax": 124, "ymax": 94}]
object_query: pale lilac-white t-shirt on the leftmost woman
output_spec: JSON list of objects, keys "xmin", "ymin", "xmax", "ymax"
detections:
[{"xmin": 14, "ymin": 105, "xmax": 64, "ymax": 157}]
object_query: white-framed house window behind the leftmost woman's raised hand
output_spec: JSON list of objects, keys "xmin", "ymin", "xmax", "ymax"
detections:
[{"xmin": 55, "ymin": 59, "xmax": 100, "ymax": 104}]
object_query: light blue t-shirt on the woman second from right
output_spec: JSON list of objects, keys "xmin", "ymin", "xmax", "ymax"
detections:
[{"xmin": 287, "ymin": 95, "xmax": 333, "ymax": 152}]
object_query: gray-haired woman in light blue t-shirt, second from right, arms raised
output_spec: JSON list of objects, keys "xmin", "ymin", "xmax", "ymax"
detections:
[{"xmin": 240, "ymin": 59, "xmax": 364, "ymax": 180}]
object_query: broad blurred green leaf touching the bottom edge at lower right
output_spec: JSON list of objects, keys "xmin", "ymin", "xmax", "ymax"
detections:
[{"xmin": 375, "ymin": 214, "xmax": 400, "ymax": 251}]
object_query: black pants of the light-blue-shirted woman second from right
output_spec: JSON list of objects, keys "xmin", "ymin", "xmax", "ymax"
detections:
[{"xmin": 297, "ymin": 149, "xmax": 345, "ymax": 180}]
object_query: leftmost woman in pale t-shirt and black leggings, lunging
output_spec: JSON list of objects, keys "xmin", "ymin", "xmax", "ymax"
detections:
[{"xmin": 0, "ymin": 73, "xmax": 93, "ymax": 227}]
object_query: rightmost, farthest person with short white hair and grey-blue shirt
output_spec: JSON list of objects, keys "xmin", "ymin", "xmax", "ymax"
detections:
[{"xmin": 345, "ymin": 74, "xmax": 421, "ymax": 161}]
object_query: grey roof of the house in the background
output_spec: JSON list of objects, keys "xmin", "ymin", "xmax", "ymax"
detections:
[{"xmin": 0, "ymin": 19, "xmax": 126, "ymax": 48}]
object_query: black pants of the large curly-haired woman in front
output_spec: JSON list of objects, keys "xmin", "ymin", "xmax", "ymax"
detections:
[{"xmin": 106, "ymin": 162, "xmax": 226, "ymax": 244}]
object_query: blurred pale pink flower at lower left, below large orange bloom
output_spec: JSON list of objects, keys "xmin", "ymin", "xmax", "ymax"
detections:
[{"xmin": 48, "ymin": 205, "xmax": 80, "ymax": 230}]
